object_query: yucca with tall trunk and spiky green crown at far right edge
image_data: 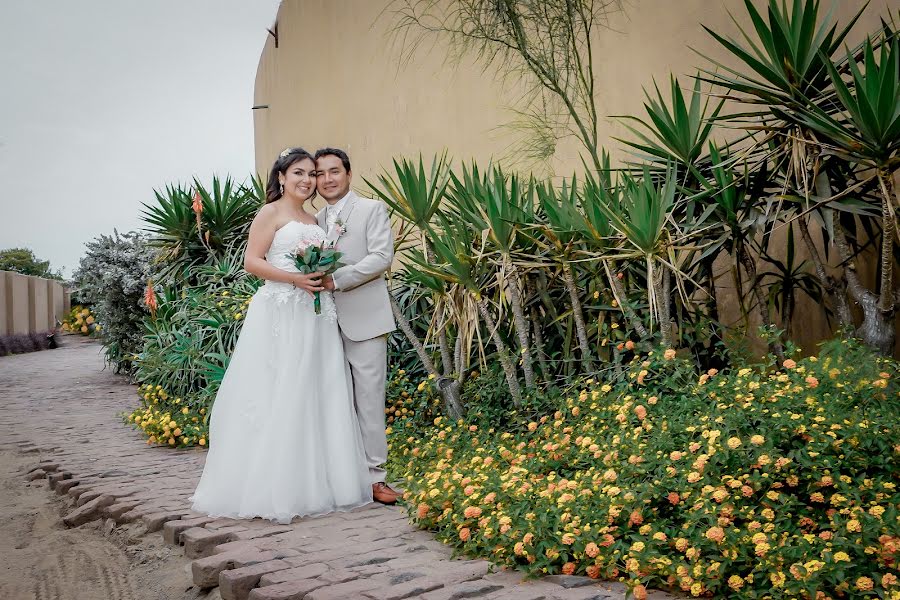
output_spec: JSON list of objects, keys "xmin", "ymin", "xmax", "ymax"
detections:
[{"xmin": 802, "ymin": 35, "xmax": 900, "ymax": 353}]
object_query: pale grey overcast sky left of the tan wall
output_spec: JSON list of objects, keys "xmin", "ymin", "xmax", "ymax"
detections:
[{"xmin": 0, "ymin": 0, "xmax": 279, "ymax": 275}]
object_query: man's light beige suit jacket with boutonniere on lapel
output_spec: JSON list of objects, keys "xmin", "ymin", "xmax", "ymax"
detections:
[{"xmin": 316, "ymin": 191, "xmax": 397, "ymax": 342}]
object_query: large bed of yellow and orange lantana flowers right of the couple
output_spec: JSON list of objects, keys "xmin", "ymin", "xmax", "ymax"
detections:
[{"xmin": 389, "ymin": 342, "xmax": 900, "ymax": 598}]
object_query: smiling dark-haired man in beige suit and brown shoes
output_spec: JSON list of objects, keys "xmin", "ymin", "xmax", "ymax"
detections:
[{"xmin": 315, "ymin": 148, "xmax": 398, "ymax": 504}]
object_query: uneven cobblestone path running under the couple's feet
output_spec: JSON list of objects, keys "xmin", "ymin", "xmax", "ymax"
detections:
[{"xmin": 0, "ymin": 336, "xmax": 672, "ymax": 600}]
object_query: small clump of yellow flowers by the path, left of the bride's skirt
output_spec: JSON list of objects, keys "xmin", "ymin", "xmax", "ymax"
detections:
[{"xmin": 125, "ymin": 384, "xmax": 209, "ymax": 448}]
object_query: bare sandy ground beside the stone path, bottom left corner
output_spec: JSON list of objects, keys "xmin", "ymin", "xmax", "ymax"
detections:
[{"xmin": 0, "ymin": 451, "xmax": 218, "ymax": 600}]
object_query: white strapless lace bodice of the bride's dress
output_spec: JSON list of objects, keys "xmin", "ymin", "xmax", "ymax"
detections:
[{"xmin": 255, "ymin": 221, "xmax": 337, "ymax": 321}]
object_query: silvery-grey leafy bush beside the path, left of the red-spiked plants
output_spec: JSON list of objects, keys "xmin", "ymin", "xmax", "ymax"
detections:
[{"xmin": 73, "ymin": 232, "xmax": 153, "ymax": 373}]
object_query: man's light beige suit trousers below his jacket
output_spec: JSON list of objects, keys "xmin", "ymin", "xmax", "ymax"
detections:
[{"xmin": 341, "ymin": 333, "xmax": 387, "ymax": 483}]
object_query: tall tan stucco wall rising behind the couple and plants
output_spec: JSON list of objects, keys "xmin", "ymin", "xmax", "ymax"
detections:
[{"xmin": 254, "ymin": 0, "xmax": 900, "ymax": 350}]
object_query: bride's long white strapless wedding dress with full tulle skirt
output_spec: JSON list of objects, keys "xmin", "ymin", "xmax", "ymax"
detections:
[{"xmin": 192, "ymin": 221, "xmax": 372, "ymax": 523}]
